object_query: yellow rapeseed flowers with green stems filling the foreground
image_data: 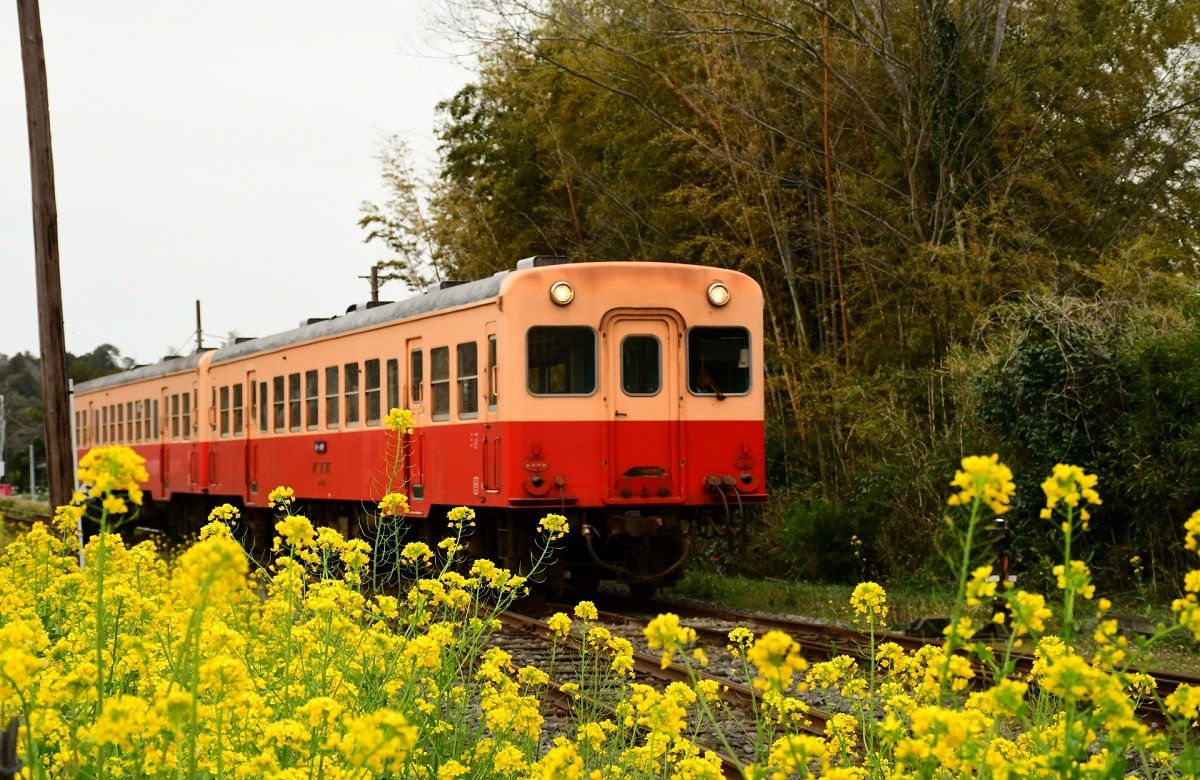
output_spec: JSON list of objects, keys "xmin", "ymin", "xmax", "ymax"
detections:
[{"xmin": 0, "ymin": 434, "xmax": 1200, "ymax": 780}]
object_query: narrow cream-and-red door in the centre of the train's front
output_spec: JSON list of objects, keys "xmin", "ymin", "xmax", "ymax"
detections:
[{"xmin": 602, "ymin": 312, "xmax": 682, "ymax": 504}]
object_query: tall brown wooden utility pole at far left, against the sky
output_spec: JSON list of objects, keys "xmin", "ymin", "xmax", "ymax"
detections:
[{"xmin": 17, "ymin": 0, "xmax": 76, "ymax": 506}]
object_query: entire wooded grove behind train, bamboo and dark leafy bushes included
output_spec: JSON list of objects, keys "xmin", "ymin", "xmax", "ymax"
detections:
[{"xmin": 361, "ymin": 0, "xmax": 1200, "ymax": 590}]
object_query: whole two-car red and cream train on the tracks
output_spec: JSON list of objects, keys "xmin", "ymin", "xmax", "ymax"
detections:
[{"xmin": 74, "ymin": 257, "xmax": 766, "ymax": 589}]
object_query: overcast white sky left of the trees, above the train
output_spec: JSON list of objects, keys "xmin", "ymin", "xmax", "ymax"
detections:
[{"xmin": 0, "ymin": 0, "xmax": 470, "ymax": 362}]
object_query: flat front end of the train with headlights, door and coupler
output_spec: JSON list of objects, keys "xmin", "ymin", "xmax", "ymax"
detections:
[{"xmin": 497, "ymin": 259, "xmax": 766, "ymax": 593}]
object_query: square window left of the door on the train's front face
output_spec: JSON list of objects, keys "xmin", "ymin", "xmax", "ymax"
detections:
[{"xmin": 526, "ymin": 325, "xmax": 596, "ymax": 396}]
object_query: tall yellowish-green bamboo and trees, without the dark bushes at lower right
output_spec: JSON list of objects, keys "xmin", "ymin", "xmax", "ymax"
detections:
[{"xmin": 403, "ymin": 0, "xmax": 1200, "ymax": 576}]
